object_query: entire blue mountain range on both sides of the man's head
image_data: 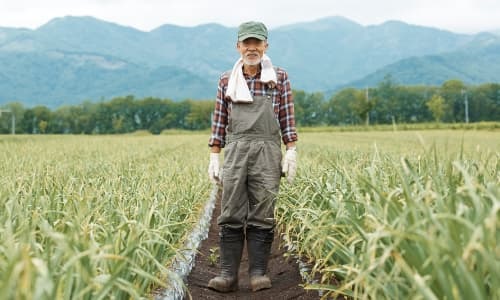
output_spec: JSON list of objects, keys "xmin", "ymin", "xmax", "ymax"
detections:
[{"xmin": 0, "ymin": 16, "xmax": 500, "ymax": 107}]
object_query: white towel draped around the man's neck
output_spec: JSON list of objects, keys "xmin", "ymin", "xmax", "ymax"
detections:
[{"xmin": 226, "ymin": 54, "xmax": 277, "ymax": 103}]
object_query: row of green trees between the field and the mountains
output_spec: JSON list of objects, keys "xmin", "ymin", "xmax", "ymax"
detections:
[{"xmin": 0, "ymin": 75, "xmax": 500, "ymax": 134}]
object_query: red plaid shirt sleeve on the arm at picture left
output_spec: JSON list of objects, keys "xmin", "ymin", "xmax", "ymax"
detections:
[{"xmin": 208, "ymin": 72, "xmax": 229, "ymax": 148}]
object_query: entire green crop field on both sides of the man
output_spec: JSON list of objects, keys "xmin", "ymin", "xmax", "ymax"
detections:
[{"xmin": 0, "ymin": 130, "xmax": 500, "ymax": 299}]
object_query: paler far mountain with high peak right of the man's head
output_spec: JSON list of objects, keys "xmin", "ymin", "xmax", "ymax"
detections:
[{"xmin": 269, "ymin": 17, "xmax": 480, "ymax": 90}]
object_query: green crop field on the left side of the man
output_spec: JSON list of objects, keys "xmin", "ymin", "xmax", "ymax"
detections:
[{"xmin": 0, "ymin": 135, "xmax": 211, "ymax": 299}]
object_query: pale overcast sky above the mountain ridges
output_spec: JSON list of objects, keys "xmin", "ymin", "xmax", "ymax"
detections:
[{"xmin": 0, "ymin": 0, "xmax": 500, "ymax": 33}]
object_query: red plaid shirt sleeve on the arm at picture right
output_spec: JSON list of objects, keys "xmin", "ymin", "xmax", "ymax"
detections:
[{"xmin": 278, "ymin": 69, "xmax": 297, "ymax": 145}]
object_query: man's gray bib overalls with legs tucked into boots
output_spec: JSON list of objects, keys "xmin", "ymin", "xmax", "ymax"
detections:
[{"xmin": 217, "ymin": 88, "xmax": 281, "ymax": 230}]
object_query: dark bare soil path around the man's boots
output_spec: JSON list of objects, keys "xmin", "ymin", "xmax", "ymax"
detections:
[{"xmin": 184, "ymin": 189, "xmax": 320, "ymax": 300}]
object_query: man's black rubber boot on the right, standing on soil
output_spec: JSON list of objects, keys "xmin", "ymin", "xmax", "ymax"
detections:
[{"xmin": 247, "ymin": 227, "xmax": 274, "ymax": 292}]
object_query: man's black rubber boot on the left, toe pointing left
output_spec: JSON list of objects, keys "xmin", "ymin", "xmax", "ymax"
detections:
[{"xmin": 208, "ymin": 227, "xmax": 245, "ymax": 293}]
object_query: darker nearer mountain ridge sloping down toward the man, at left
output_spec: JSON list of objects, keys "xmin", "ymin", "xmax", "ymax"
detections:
[{"xmin": 0, "ymin": 51, "xmax": 215, "ymax": 107}]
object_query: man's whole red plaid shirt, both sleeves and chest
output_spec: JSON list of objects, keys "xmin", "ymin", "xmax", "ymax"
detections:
[{"xmin": 208, "ymin": 68, "xmax": 297, "ymax": 148}]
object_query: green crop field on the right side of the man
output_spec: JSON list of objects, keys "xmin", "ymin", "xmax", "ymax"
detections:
[{"xmin": 277, "ymin": 131, "xmax": 500, "ymax": 299}]
